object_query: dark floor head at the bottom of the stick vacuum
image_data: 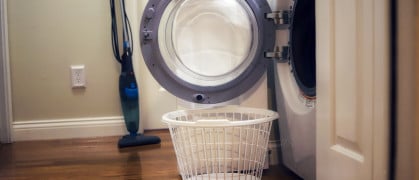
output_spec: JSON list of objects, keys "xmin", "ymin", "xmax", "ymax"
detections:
[{"xmin": 118, "ymin": 134, "xmax": 161, "ymax": 148}]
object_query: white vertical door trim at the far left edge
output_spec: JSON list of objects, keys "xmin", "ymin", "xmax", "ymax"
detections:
[{"xmin": 0, "ymin": 0, "xmax": 13, "ymax": 143}]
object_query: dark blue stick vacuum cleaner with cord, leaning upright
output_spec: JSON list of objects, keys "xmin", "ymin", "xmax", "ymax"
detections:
[{"xmin": 110, "ymin": 0, "xmax": 160, "ymax": 148}]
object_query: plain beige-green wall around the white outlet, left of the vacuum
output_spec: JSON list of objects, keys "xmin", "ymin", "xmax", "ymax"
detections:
[{"xmin": 8, "ymin": 0, "xmax": 121, "ymax": 121}]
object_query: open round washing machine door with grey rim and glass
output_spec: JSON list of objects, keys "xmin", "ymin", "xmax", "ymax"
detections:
[{"xmin": 141, "ymin": 0, "xmax": 275, "ymax": 104}]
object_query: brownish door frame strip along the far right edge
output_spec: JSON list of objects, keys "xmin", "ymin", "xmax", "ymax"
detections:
[{"xmin": 392, "ymin": 0, "xmax": 418, "ymax": 179}]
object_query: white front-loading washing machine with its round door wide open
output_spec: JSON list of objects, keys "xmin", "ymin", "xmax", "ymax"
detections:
[{"xmin": 140, "ymin": 0, "xmax": 316, "ymax": 179}]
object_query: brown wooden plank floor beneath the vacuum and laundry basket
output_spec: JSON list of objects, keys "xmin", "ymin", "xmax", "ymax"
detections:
[{"xmin": 0, "ymin": 130, "xmax": 302, "ymax": 180}]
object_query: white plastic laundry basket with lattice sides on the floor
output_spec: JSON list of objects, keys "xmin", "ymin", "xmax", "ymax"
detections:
[{"xmin": 163, "ymin": 106, "xmax": 278, "ymax": 180}]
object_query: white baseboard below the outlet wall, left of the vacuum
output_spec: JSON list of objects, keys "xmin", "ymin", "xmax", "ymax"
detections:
[{"xmin": 13, "ymin": 116, "xmax": 127, "ymax": 141}]
